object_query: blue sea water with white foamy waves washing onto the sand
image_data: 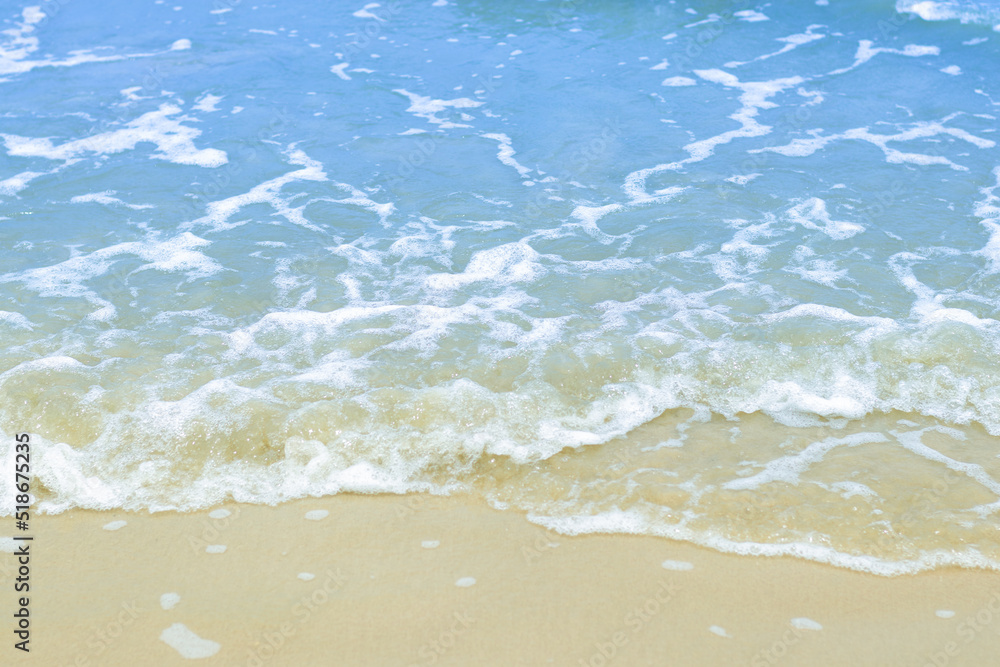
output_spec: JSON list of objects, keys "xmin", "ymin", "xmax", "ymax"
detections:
[{"xmin": 0, "ymin": 0, "xmax": 1000, "ymax": 574}]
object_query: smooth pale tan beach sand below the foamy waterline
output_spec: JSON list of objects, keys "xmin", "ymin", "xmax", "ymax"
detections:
[{"xmin": 0, "ymin": 494, "xmax": 1000, "ymax": 667}]
